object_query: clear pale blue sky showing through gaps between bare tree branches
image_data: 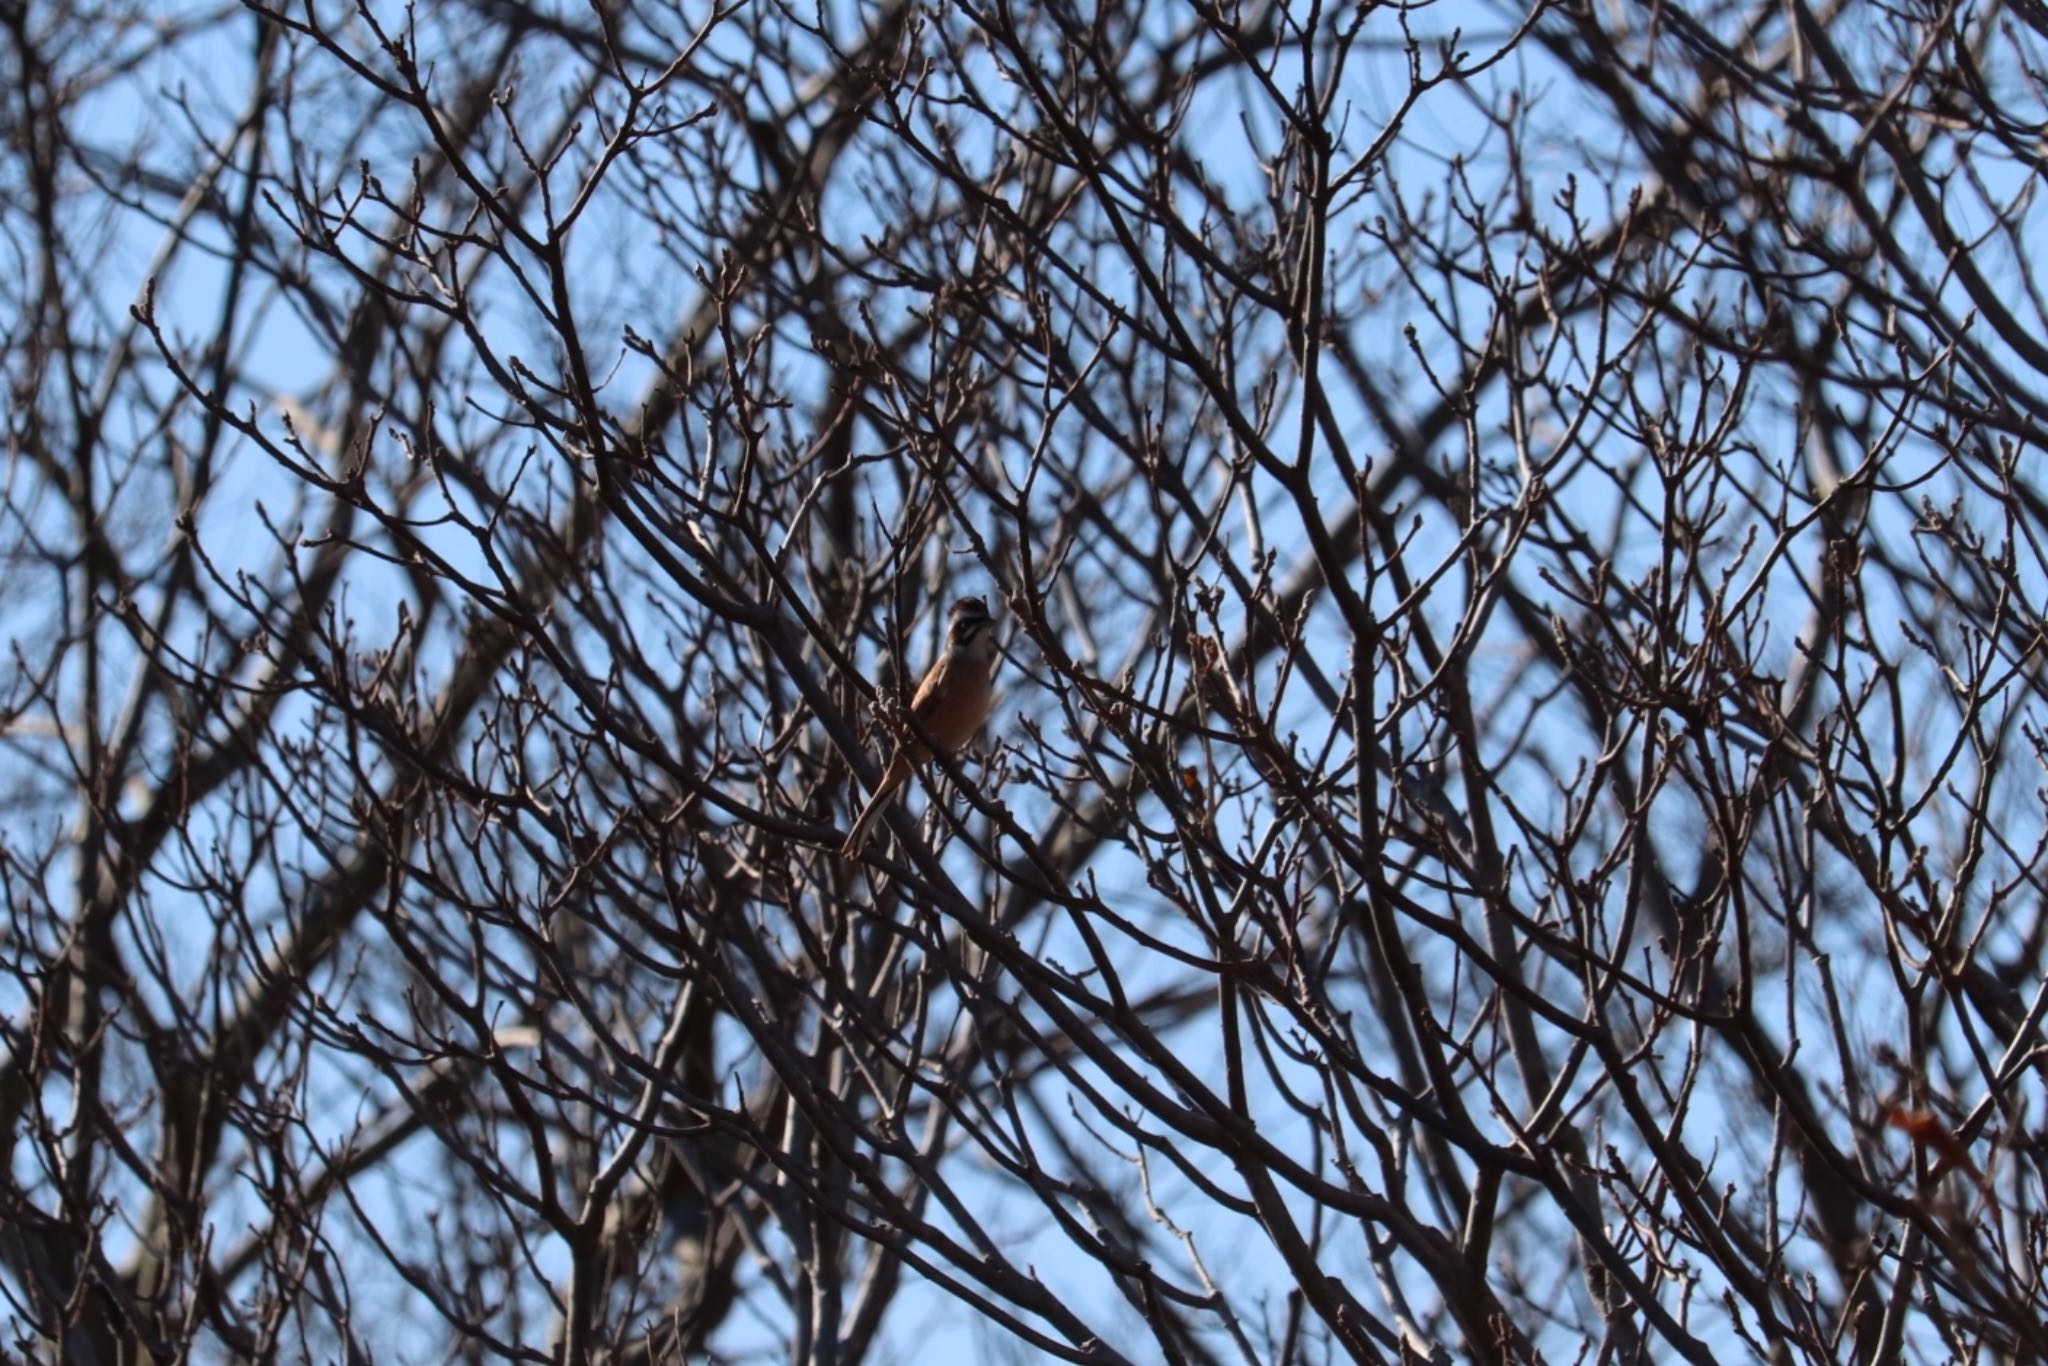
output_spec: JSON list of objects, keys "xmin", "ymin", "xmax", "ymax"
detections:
[{"xmin": 12, "ymin": 8, "xmax": 2032, "ymax": 1362}]
